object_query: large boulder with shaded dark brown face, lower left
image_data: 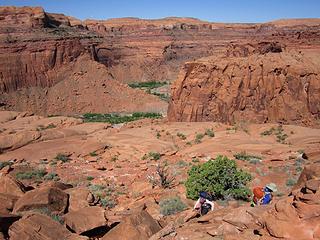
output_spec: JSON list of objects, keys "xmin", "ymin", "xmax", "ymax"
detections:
[{"xmin": 13, "ymin": 187, "xmax": 68, "ymax": 214}]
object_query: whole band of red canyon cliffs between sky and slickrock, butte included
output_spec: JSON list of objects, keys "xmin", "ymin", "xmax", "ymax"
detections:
[{"xmin": 0, "ymin": 7, "xmax": 320, "ymax": 122}]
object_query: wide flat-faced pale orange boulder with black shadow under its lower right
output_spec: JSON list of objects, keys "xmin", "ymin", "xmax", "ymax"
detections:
[{"xmin": 64, "ymin": 207, "xmax": 107, "ymax": 235}]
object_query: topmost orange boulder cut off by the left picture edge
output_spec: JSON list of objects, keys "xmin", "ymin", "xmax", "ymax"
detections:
[{"xmin": 0, "ymin": 174, "xmax": 26, "ymax": 197}]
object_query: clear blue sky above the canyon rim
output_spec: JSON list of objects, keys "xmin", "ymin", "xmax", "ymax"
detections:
[{"xmin": 0, "ymin": 0, "xmax": 320, "ymax": 22}]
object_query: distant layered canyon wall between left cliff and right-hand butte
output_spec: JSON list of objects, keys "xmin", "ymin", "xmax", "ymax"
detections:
[{"xmin": 84, "ymin": 18, "xmax": 320, "ymax": 82}]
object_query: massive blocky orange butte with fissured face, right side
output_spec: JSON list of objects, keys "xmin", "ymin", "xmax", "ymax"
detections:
[{"xmin": 168, "ymin": 51, "xmax": 320, "ymax": 124}]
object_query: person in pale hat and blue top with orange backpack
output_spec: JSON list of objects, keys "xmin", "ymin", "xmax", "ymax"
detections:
[{"xmin": 251, "ymin": 183, "xmax": 277, "ymax": 206}]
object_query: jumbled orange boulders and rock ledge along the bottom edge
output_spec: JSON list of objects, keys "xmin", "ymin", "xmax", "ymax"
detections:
[{"xmin": 0, "ymin": 162, "xmax": 320, "ymax": 240}]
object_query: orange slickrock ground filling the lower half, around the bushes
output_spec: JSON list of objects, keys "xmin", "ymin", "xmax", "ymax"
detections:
[{"xmin": 0, "ymin": 111, "xmax": 320, "ymax": 240}]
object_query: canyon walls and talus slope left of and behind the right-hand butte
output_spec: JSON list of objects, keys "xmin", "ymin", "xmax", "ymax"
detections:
[{"xmin": 0, "ymin": 7, "xmax": 320, "ymax": 117}]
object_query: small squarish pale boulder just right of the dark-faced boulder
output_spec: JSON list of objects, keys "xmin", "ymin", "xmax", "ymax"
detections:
[{"xmin": 64, "ymin": 188, "xmax": 96, "ymax": 212}]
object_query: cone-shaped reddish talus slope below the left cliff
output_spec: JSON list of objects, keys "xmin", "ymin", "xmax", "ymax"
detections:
[{"xmin": 0, "ymin": 55, "xmax": 167, "ymax": 115}]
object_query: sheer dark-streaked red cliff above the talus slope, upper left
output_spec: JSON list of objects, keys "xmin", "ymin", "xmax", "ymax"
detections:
[{"xmin": 0, "ymin": 7, "xmax": 100, "ymax": 92}]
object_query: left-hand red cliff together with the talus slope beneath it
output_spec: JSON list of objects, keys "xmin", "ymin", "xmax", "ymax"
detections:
[{"xmin": 0, "ymin": 7, "xmax": 167, "ymax": 114}]
